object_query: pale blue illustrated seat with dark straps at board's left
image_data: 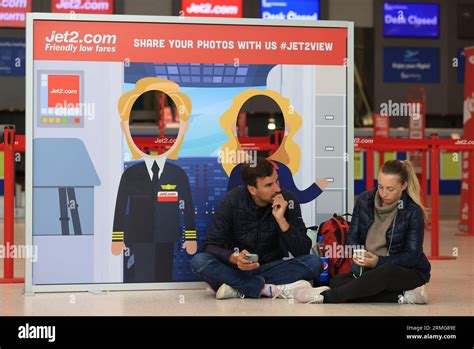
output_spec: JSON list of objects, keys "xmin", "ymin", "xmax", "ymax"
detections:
[{"xmin": 33, "ymin": 138, "xmax": 101, "ymax": 285}]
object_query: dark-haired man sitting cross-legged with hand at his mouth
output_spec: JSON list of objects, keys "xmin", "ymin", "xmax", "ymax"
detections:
[{"xmin": 191, "ymin": 158, "xmax": 322, "ymax": 299}]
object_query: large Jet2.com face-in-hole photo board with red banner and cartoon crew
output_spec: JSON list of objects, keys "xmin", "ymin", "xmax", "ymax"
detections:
[{"xmin": 25, "ymin": 13, "xmax": 353, "ymax": 294}]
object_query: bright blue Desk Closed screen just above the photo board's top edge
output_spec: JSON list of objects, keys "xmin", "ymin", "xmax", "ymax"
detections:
[{"xmin": 260, "ymin": 0, "xmax": 320, "ymax": 21}]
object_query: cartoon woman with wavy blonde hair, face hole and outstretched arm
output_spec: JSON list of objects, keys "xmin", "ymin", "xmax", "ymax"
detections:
[{"xmin": 220, "ymin": 89, "xmax": 328, "ymax": 203}]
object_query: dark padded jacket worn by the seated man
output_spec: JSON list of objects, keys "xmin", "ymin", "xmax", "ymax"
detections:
[{"xmin": 203, "ymin": 186, "xmax": 311, "ymax": 264}]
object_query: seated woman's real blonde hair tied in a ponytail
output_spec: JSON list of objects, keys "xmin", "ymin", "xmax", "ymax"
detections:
[{"xmin": 380, "ymin": 160, "xmax": 429, "ymax": 221}]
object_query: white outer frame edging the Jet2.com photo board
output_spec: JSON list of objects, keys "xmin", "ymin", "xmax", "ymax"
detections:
[{"xmin": 25, "ymin": 13, "xmax": 354, "ymax": 295}]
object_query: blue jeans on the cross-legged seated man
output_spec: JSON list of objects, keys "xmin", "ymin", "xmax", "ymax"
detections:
[{"xmin": 191, "ymin": 253, "xmax": 323, "ymax": 298}]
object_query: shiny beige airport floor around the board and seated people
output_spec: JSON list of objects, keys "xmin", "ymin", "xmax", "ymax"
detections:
[{"xmin": 0, "ymin": 220, "xmax": 474, "ymax": 316}]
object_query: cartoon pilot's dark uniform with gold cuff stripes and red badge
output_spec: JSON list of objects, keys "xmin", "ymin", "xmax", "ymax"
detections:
[{"xmin": 112, "ymin": 162, "xmax": 196, "ymax": 282}]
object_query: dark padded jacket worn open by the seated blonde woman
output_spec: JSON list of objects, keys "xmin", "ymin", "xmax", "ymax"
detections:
[{"xmin": 346, "ymin": 189, "xmax": 431, "ymax": 282}]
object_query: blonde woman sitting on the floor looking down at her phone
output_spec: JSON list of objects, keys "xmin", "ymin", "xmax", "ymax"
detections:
[{"xmin": 295, "ymin": 160, "xmax": 431, "ymax": 304}]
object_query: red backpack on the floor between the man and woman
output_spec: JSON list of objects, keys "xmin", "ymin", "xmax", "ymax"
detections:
[{"xmin": 318, "ymin": 213, "xmax": 352, "ymax": 277}]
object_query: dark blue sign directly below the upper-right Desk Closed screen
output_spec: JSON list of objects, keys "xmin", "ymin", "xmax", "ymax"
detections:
[{"xmin": 383, "ymin": 47, "xmax": 440, "ymax": 83}]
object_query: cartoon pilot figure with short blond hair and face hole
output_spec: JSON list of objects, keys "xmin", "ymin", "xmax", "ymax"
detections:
[{"xmin": 112, "ymin": 78, "xmax": 197, "ymax": 283}]
